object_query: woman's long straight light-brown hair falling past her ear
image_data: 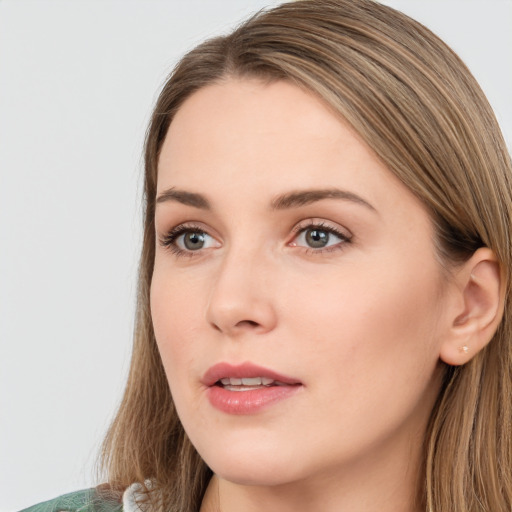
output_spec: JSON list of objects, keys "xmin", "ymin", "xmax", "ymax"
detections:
[{"xmin": 102, "ymin": 0, "xmax": 512, "ymax": 512}]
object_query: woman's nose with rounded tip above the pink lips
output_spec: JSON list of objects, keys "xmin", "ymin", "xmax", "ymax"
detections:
[{"xmin": 206, "ymin": 247, "xmax": 277, "ymax": 337}]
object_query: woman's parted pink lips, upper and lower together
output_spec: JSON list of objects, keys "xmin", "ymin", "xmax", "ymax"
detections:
[{"xmin": 201, "ymin": 363, "xmax": 303, "ymax": 415}]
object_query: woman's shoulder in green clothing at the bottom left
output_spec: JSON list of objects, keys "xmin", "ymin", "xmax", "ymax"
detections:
[{"xmin": 20, "ymin": 489, "xmax": 123, "ymax": 512}]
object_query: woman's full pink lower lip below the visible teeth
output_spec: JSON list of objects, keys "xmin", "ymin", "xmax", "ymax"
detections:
[{"xmin": 207, "ymin": 385, "xmax": 302, "ymax": 414}]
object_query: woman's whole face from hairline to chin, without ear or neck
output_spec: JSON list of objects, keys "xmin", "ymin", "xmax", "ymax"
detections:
[{"xmin": 151, "ymin": 79, "xmax": 445, "ymax": 485}]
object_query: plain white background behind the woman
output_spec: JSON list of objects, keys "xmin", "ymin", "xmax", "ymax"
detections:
[{"xmin": 0, "ymin": 0, "xmax": 512, "ymax": 512}]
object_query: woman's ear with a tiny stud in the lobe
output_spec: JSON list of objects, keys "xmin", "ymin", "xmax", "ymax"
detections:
[{"xmin": 439, "ymin": 247, "xmax": 505, "ymax": 366}]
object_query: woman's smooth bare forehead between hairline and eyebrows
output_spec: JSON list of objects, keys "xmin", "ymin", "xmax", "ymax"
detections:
[{"xmin": 158, "ymin": 79, "xmax": 424, "ymax": 224}]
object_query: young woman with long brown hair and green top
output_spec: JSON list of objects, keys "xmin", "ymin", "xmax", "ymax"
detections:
[{"xmin": 24, "ymin": 0, "xmax": 512, "ymax": 512}]
